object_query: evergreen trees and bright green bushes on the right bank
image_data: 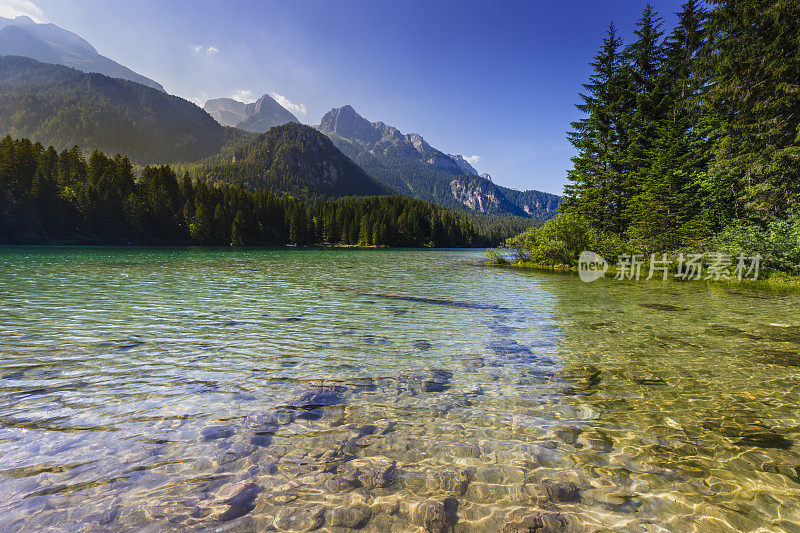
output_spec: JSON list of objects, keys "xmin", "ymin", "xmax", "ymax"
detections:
[{"xmin": 552, "ymin": 0, "xmax": 800, "ymax": 271}]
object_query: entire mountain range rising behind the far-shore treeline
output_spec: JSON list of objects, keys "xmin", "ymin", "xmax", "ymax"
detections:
[{"xmin": 0, "ymin": 17, "xmax": 560, "ymax": 220}]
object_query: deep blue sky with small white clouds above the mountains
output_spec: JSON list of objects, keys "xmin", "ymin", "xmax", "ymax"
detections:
[{"xmin": 0, "ymin": 0, "xmax": 680, "ymax": 193}]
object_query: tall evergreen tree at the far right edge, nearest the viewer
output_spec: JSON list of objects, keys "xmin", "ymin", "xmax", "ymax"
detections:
[{"xmin": 706, "ymin": 0, "xmax": 800, "ymax": 223}]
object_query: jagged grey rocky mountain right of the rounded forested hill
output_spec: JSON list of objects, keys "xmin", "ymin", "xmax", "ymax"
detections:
[{"xmin": 317, "ymin": 105, "xmax": 560, "ymax": 220}]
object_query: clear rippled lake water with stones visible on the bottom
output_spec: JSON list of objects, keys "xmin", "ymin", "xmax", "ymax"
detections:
[{"xmin": 0, "ymin": 248, "xmax": 800, "ymax": 532}]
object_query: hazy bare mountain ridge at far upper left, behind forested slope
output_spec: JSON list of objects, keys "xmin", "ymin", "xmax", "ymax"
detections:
[{"xmin": 0, "ymin": 17, "xmax": 164, "ymax": 91}]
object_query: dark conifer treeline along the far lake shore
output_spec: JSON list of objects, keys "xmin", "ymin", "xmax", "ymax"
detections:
[{"xmin": 0, "ymin": 137, "xmax": 491, "ymax": 247}]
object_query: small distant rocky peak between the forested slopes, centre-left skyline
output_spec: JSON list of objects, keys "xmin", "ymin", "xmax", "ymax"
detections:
[{"xmin": 203, "ymin": 94, "xmax": 300, "ymax": 133}]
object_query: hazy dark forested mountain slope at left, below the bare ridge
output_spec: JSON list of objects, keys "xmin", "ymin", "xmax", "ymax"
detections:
[{"xmin": 0, "ymin": 56, "xmax": 231, "ymax": 164}]
